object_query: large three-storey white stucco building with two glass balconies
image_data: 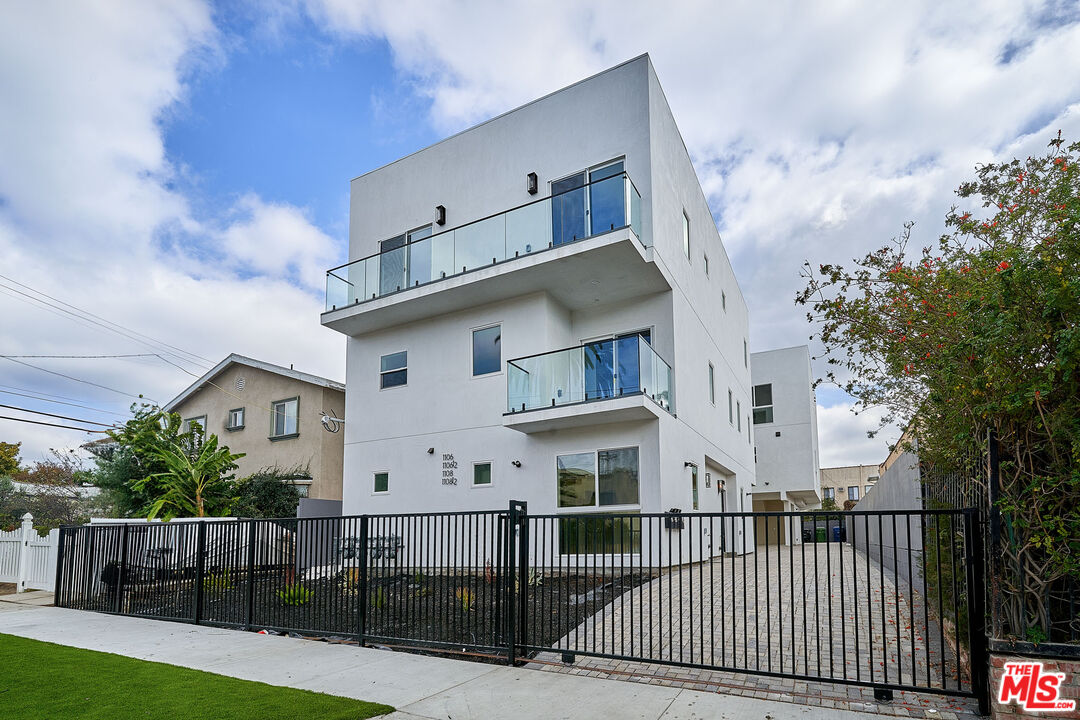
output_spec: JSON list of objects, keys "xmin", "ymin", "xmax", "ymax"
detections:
[{"xmin": 322, "ymin": 55, "xmax": 755, "ymax": 553}]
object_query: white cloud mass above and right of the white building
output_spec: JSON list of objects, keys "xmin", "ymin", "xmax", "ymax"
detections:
[{"xmin": 309, "ymin": 0, "xmax": 1080, "ymax": 462}]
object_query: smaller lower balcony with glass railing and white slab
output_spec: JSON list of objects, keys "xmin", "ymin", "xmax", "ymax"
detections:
[{"xmin": 503, "ymin": 334, "xmax": 675, "ymax": 433}]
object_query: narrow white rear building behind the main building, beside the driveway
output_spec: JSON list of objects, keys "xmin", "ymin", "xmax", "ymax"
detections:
[{"xmin": 751, "ymin": 345, "xmax": 821, "ymax": 544}]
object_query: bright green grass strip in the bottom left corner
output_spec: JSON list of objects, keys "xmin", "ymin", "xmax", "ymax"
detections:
[{"xmin": 0, "ymin": 635, "xmax": 393, "ymax": 720}]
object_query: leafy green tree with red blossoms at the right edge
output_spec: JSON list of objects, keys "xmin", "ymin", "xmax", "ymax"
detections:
[{"xmin": 797, "ymin": 134, "xmax": 1080, "ymax": 636}]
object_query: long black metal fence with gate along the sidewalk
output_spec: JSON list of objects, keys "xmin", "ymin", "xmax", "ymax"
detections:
[{"xmin": 56, "ymin": 502, "xmax": 986, "ymax": 697}]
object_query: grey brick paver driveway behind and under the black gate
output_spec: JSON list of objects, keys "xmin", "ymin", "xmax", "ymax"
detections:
[{"xmin": 527, "ymin": 543, "xmax": 975, "ymax": 718}]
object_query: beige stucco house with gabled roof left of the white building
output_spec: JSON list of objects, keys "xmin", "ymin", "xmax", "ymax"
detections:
[{"xmin": 164, "ymin": 354, "xmax": 345, "ymax": 500}]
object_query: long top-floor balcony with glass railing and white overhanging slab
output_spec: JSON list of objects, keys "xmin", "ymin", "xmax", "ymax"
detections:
[{"xmin": 322, "ymin": 172, "xmax": 669, "ymax": 335}]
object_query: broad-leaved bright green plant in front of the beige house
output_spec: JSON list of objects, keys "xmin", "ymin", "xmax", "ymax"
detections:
[{"xmin": 135, "ymin": 431, "xmax": 244, "ymax": 519}]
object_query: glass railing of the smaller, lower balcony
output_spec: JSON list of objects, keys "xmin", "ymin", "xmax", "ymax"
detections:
[{"xmin": 507, "ymin": 335, "xmax": 675, "ymax": 413}]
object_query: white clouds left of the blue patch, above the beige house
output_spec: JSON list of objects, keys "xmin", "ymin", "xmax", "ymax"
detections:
[{"xmin": 0, "ymin": 0, "xmax": 345, "ymax": 460}]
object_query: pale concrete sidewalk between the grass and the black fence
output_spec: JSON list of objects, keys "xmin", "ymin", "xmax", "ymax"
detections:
[{"xmin": 0, "ymin": 596, "xmax": 907, "ymax": 720}]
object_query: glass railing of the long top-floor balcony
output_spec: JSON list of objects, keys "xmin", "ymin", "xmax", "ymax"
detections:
[{"xmin": 326, "ymin": 172, "xmax": 644, "ymax": 311}]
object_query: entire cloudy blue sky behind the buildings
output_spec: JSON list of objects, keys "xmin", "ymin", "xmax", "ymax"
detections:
[{"xmin": 0, "ymin": 0, "xmax": 1080, "ymax": 465}]
